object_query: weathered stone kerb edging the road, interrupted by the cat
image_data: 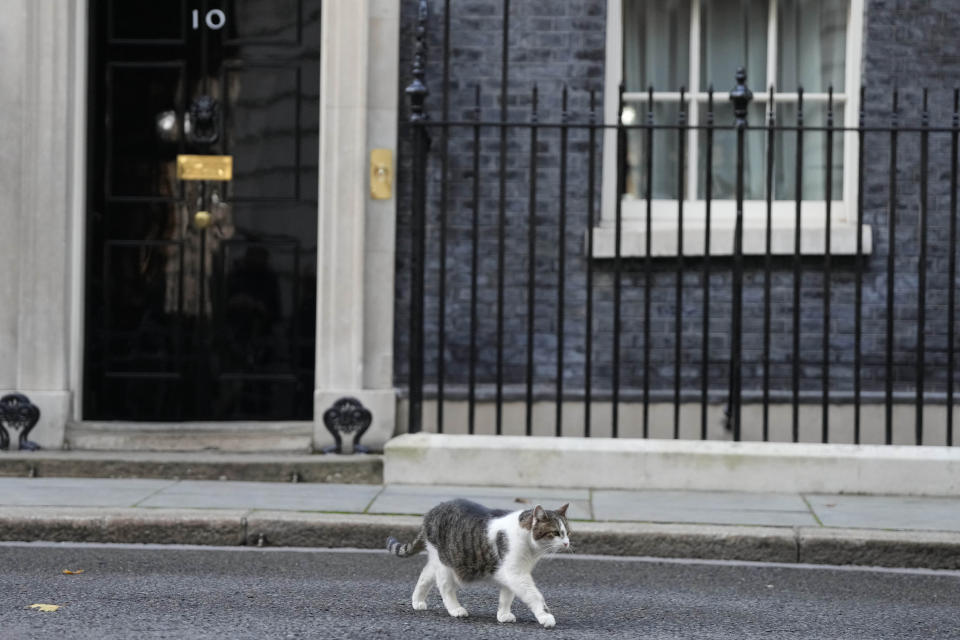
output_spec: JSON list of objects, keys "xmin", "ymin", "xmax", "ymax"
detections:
[{"xmin": 0, "ymin": 507, "xmax": 960, "ymax": 570}]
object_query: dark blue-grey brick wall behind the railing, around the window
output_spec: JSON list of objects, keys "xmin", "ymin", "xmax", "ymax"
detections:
[{"xmin": 396, "ymin": 0, "xmax": 960, "ymax": 408}]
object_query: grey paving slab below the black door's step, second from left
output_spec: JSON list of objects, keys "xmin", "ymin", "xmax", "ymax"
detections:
[{"xmin": 137, "ymin": 480, "xmax": 382, "ymax": 513}]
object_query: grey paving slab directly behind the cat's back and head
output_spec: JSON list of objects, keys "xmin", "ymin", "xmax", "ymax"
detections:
[{"xmin": 368, "ymin": 484, "xmax": 592, "ymax": 520}]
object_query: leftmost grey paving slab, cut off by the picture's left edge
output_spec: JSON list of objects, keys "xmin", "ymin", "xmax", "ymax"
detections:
[{"xmin": 0, "ymin": 478, "xmax": 175, "ymax": 507}]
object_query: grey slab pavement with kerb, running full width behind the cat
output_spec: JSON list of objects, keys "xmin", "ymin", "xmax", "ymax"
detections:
[{"xmin": 0, "ymin": 478, "xmax": 960, "ymax": 569}]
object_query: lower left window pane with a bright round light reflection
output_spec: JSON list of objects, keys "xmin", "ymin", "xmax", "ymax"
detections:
[{"xmin": 624, "ymin": 102, "xmax": 691, "ymax": 199}]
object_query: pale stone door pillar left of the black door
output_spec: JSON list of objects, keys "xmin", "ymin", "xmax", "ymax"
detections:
[{"xmin": 0, "ymin": 0, "xmax": 87, "ymax": 449}]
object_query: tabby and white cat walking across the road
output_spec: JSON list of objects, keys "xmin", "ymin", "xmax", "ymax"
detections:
[{"xmin": 387, "ymin": 500, "xmax": 570, "ymax": 629}]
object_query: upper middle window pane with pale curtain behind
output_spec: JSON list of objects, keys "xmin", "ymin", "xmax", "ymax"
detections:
[{"xmin": 700, "ymin": 0, "xmax": 768, "ymax": 91}]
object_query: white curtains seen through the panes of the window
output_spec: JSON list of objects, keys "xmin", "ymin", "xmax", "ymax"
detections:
[{"xmin": 623, "ymin": 0, "xmax": 848, "ymax": 199}]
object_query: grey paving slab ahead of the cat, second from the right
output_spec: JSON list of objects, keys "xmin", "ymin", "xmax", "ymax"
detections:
[{"xmin": 593, "ymin": 490, "xmax": 817, "ymax": 527}]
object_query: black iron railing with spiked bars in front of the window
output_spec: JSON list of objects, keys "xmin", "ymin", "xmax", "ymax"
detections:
[{"xmin": 400, "ymin": 2, "xmax": 960, "ymax": 445}]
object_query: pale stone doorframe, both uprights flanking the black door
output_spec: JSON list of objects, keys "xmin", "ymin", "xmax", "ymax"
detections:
[{"xmin": 0, "ymin": 0, "xmax": 400, "ymax": 449}]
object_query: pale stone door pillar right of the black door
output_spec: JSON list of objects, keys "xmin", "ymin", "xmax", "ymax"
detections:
[{"xmin": 313, "ymin": 0, "xmax": 400, "ymax": 448}]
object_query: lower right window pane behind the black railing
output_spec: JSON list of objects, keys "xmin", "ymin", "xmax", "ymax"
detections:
[{"xmin": 773, "ymin": 103, "xmax": 844, "ymax": 200}]
